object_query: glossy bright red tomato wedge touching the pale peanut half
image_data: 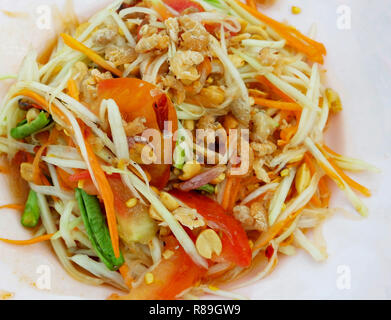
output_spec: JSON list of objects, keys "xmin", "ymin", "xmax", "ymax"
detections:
[{"xmin": 170, "ymin": 190, "xmax": 252, "ymax": 267}]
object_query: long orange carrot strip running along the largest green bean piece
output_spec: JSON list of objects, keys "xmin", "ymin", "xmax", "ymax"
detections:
[{"xmin": 84, "ymin": 130, "xmax": 120, "ymax": 258}]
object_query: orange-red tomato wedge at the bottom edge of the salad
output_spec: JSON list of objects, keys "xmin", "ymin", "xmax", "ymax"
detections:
[{"xmin": 111, "ymin": 237, "xmax": 206, "ymax": 300}]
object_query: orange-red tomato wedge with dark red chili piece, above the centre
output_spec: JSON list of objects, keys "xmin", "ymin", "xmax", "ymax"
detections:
[{"xmin": 98, "ymin": 78, "xmax": 178, "ymax": 189}]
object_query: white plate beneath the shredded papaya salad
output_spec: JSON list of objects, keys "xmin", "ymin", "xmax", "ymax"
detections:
[{"xmin": 0, "ymin": 0, "xmax": 391, "ymax": 299}]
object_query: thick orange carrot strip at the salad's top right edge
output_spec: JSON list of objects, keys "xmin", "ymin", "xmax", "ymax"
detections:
[{"xmin": 235, "ymin": 0, "xmax": 326, "ymax": 64}]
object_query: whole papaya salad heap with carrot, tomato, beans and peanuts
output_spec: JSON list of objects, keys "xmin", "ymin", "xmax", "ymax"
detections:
[{"xmin": 0, "ymin": 0, "xmax": 376, "ymax": 299}]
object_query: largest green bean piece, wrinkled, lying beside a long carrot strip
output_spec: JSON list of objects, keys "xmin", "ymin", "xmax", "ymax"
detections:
[{"xmin": 76, "ymin": 189, "xmax": 124, "ymax": 271}]
